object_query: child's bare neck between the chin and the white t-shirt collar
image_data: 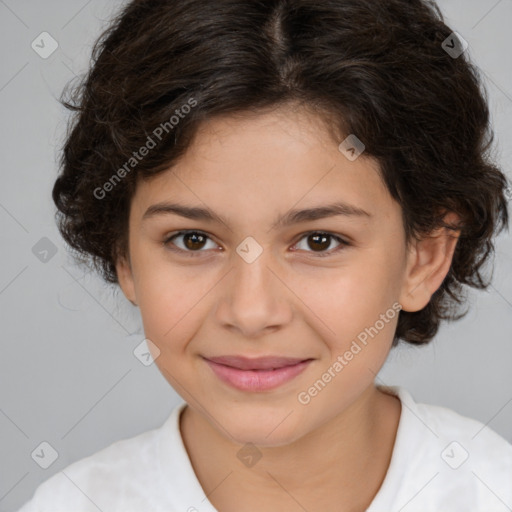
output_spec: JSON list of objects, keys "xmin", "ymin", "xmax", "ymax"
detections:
[{"xmin": 180, "ymin": 383, "xmax": 400, "ymax": 512}]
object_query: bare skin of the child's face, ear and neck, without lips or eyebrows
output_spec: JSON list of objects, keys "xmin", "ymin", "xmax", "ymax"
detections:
[{"xmin": 117, "ymin": 107, "xmax": 457, "ymax": 512}]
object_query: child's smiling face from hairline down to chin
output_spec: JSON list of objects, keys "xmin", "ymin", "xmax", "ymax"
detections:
[{"xmin": 117, "ymin": 109, "xmax": 456, "ymax": 446}]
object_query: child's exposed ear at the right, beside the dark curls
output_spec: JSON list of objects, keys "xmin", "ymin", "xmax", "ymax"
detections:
[{"xmin": 400, "ymin": 212, "xmax": 460, "ymax": 312}]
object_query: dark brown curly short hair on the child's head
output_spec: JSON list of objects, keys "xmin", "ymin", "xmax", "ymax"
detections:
[{"xmin": 53, "ymin": 0, "xmax": 508, "ymax": 346}]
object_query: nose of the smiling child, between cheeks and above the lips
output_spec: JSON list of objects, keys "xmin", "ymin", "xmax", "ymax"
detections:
[{"xmin": 216, "ymin": 245, "xmax": 293, "ymax": 338}]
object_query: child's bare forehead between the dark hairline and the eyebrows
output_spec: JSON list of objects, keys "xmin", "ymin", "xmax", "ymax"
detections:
[{"xmin": 134, "ymin": 108, "xmax": 396, "ymax": 224}]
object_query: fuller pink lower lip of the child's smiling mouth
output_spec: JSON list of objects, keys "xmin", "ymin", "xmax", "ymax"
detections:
[{"xmin": 206, "ymin": 359, "xmax": 312, "ymax": 391}]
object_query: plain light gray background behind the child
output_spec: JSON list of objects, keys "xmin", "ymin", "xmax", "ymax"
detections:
[{"xmin": 0, "ymin": 0, "xmax": 512, "ymax": 512}]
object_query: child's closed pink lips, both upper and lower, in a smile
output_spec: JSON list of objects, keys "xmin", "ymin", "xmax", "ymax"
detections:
[{"xmin": 206, "ymin": 356, "xmax": 312, "ymax": 391}]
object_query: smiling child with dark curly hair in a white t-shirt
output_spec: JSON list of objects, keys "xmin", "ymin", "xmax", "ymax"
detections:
[{"xmin": 21, "ymin": 0, "xmax": 512, "ymax": 512}]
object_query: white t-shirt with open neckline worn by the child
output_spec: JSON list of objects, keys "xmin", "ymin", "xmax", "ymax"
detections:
[{"xmin": 19, "ymin": 386, "xmax": 512, "ymax": 512}]
